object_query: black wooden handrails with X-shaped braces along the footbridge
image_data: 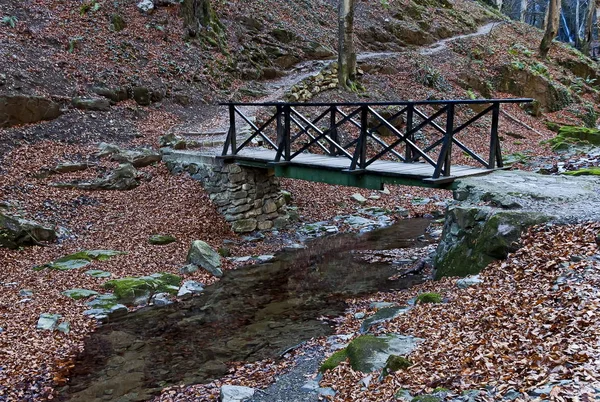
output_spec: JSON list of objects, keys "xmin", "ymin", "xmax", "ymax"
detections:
[{"xmin": 220, "ymin": 98, "xmax": 533, "ymax": 179}]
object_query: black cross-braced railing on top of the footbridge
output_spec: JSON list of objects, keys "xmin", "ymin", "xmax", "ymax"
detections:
[{"xmin": 221, "ymin": 99, "xmax": 532, "ymax": 179}]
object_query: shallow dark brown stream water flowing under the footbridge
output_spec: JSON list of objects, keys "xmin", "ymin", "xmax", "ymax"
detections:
[{"xmin": 61, "ymin": 219, "xmax": 429, "ymax": 402}]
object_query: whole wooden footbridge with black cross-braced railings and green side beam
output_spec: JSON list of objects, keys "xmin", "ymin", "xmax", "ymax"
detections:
[{"xmin": 221, "ymin": 99, "xmax": 532, "ymax": 189}]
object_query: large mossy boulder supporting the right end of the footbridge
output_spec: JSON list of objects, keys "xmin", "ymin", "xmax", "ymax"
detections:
[{"xmin": 434, "ymin": 206, "xmax": 550, "ymax": 279}]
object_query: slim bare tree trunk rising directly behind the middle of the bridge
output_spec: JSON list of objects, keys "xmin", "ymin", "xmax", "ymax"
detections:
[{"xmin": 338, "ymin": 0, "xmax": 356, "ymax": 89}]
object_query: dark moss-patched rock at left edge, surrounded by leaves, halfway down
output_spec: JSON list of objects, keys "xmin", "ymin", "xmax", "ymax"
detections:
[{"xmin": 0, "ymin": 212, "xmax": 58, "ymax": 249}]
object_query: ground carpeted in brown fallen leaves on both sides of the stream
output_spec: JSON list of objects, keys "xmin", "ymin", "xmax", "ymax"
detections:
[{"xmin": 0, "ymin": 0, "xmax": 598, "ymax": 401}]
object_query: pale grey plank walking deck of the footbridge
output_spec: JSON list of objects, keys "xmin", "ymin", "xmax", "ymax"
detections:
[{"xmin": 234, "ymin": 148, "xmax": 494, "ymax": 186}]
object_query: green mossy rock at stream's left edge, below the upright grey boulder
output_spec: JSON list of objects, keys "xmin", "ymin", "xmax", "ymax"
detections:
[{"xmin": 104, "ymin": 273, "xmax": 181, "ymax": 305}]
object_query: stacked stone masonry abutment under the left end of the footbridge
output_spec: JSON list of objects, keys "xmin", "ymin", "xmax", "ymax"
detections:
[{"xmin": 163, "ymin": 151, "xmax": 289, "ymax": 233}]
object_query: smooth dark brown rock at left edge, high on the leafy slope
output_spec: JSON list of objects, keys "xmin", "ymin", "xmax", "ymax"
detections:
[{"xmin": 0, "ymin": 95, "xmax": 61, "ymax": 127}]
